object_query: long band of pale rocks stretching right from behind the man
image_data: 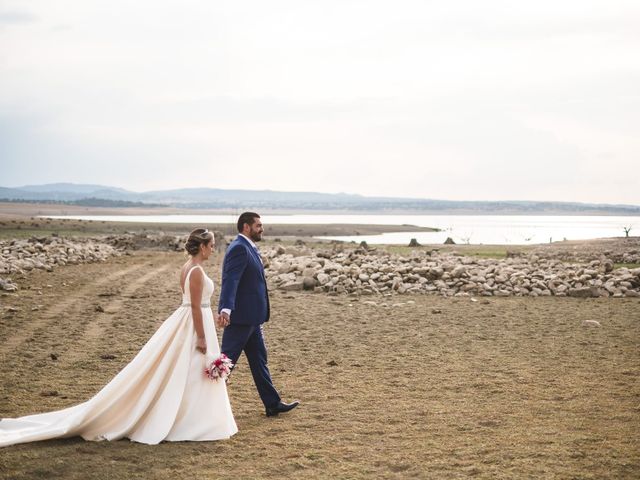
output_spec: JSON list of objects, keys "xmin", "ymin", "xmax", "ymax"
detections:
[{"xmin": 264, "ymin": 246, "xmax": 640, "ymax": 297}]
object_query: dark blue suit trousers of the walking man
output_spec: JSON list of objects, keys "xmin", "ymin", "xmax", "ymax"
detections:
[{"xmin": 221, "ymin": 323, "xmax": 280, "ymax": 407}]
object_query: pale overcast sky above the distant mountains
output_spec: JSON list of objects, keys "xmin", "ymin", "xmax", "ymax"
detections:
[{"xmin": 0, "ymin": 0, "xmax": 640, "ymax": 205}]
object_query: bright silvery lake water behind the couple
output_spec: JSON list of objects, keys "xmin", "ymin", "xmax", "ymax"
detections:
[{"xmin": 42, "ymin": 214, "xmax": 640, "ymax": 245}]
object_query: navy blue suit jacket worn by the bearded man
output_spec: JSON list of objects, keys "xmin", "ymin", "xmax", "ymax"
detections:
[{"xmin": 218, "ymin": 235, "xmax": 269, "ymax": 325}]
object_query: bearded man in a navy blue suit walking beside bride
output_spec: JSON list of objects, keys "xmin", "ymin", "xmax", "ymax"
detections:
[{"xmin": 218, "ymin": 212, "xmax": 299, "ymax": 417}]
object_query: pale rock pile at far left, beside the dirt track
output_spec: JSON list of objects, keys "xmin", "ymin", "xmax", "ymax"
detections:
[{"xmin": 0, "ymin": 236, "xmax": 122, "ymax": 282}]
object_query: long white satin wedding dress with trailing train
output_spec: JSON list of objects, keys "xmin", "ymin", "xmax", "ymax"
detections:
[{"xmin": 0, "ymin": 267, "xmax": 238, "ymax": 447}]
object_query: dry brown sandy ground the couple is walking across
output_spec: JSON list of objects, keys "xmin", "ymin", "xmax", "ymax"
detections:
[{"xmin": 0, "ymin": 246, "xmax": 640, "ymax": 479}]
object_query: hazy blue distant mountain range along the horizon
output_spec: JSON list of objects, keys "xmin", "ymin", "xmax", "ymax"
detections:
[{"xmin": 0, "ymin": 183, "xmax": 640, "ymax": 215}]
